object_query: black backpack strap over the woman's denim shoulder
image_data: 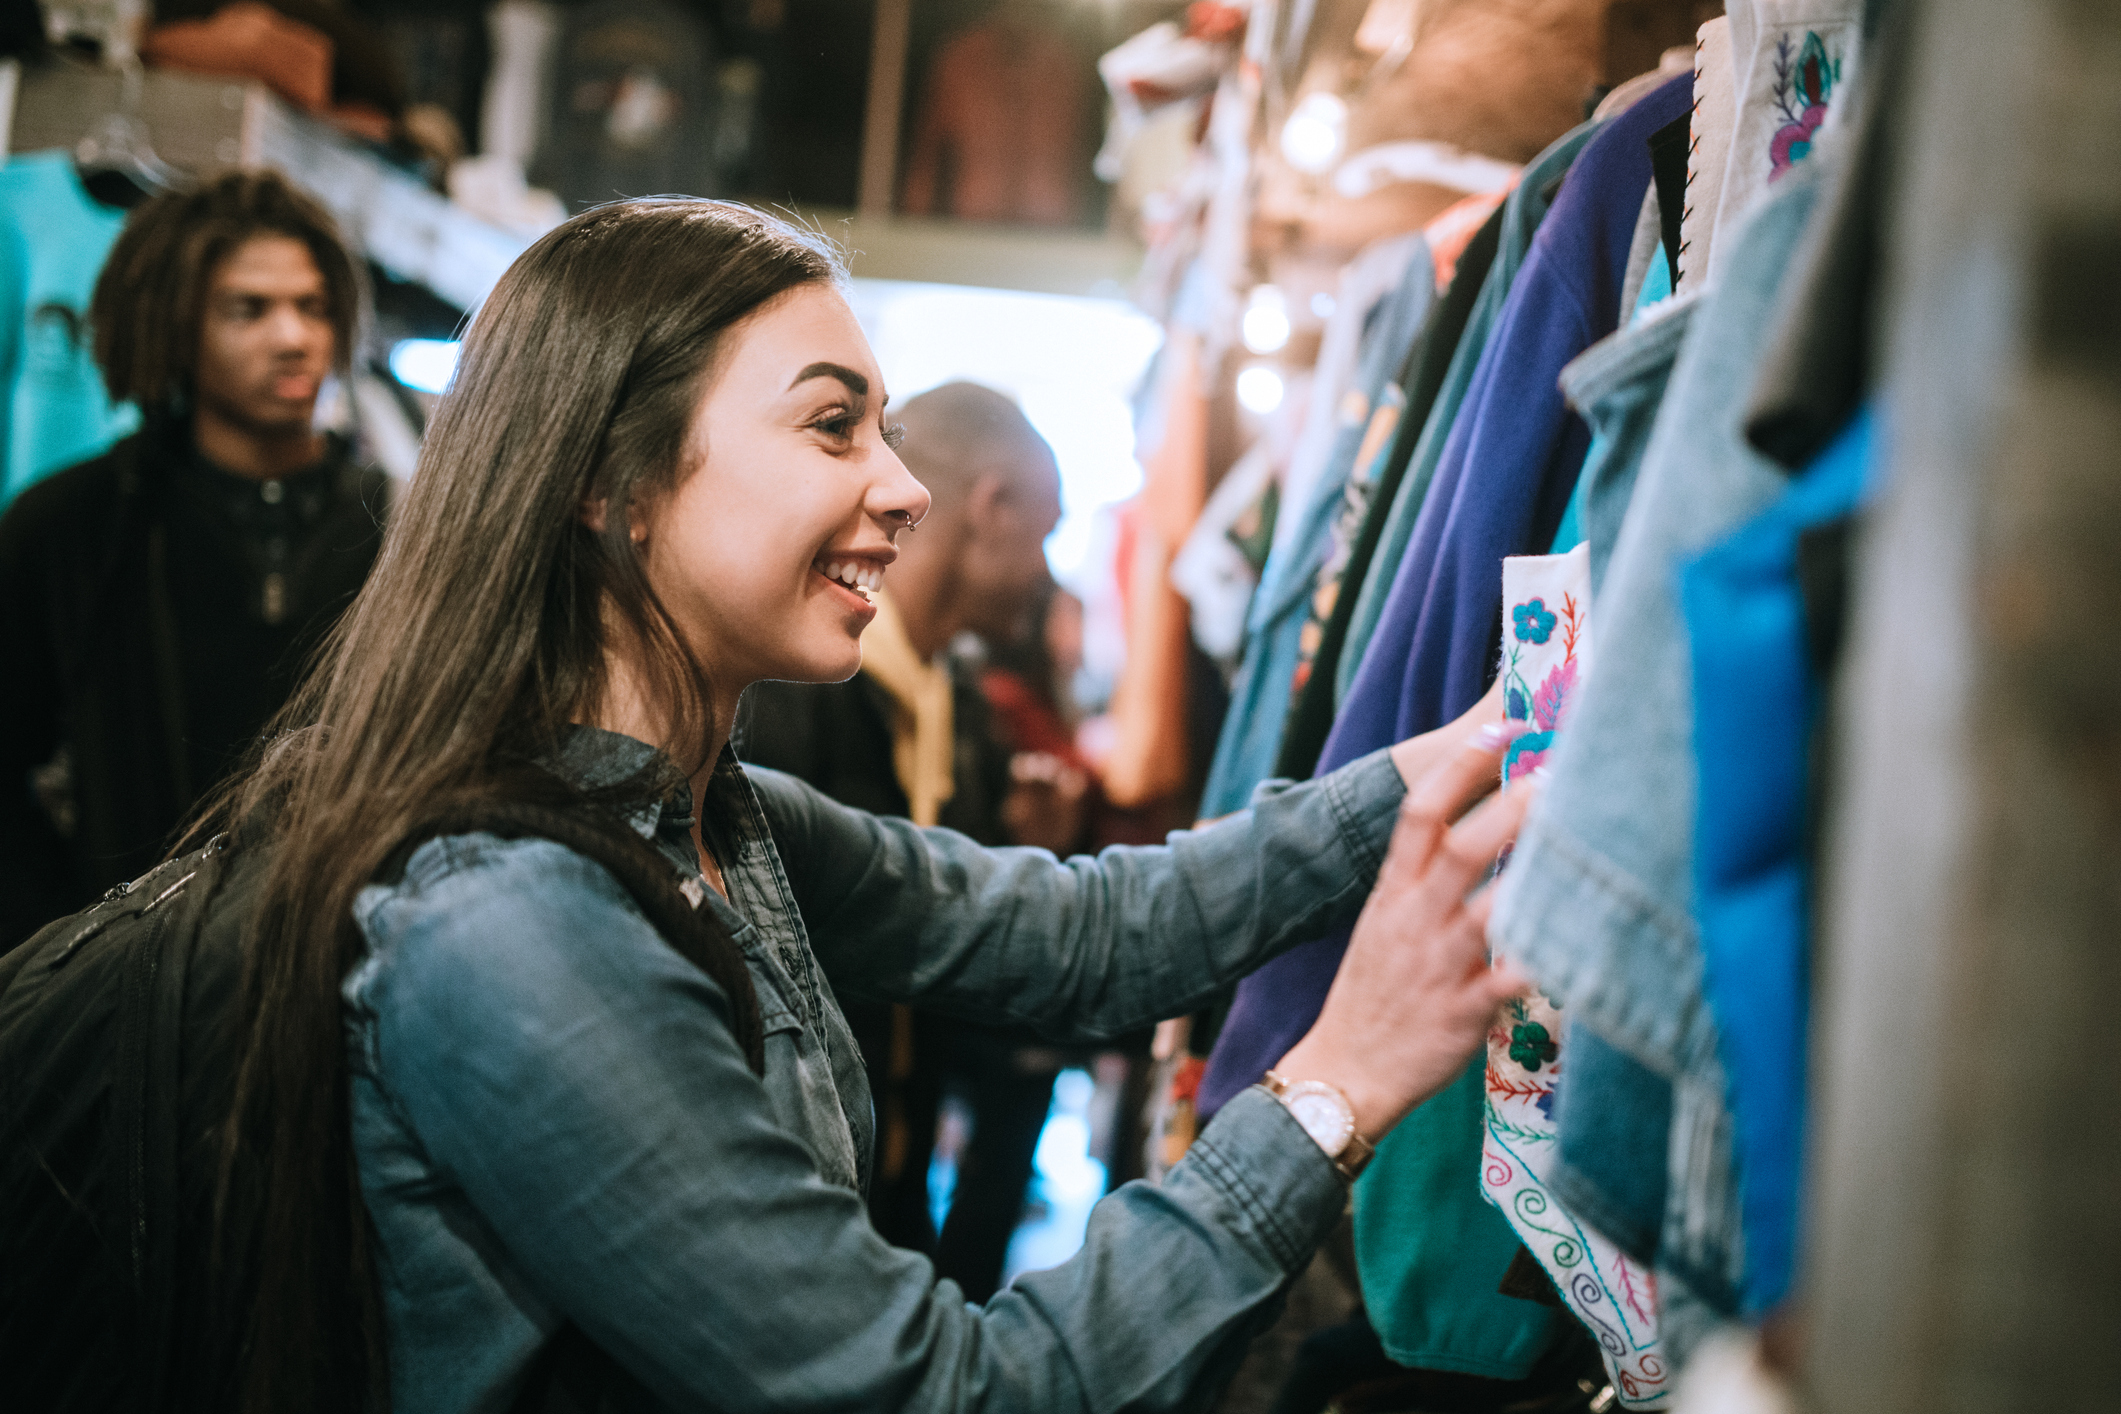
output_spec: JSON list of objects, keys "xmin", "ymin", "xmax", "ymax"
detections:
[{"xmin": 384, "ymin": 799, "xmax": 766, "ymax": 1075}]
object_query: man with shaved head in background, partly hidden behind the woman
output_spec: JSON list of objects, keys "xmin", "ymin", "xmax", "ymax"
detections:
[{"xmin": 736, "ymin": 384, "xmax": 1082, "ymax": 1302}]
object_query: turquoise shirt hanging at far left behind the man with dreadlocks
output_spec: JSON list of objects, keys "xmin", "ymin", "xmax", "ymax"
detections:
[{"xmin": 0, "ymin": 153, "xmax": 140, "ymax": 511}]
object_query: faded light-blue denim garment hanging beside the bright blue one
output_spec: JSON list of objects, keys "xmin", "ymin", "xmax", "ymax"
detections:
[{"xmin": 1489, "ymin": 159, "xmax": 1826, "ymax": 1331}]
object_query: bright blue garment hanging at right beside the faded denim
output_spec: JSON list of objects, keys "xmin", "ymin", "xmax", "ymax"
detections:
[{"xmin": 1680, "ymin": 409, "xmax": 1877, "ymax": 1316}]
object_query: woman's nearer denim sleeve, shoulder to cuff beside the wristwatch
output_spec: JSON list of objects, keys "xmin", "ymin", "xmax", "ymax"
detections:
[{"xmin": 348, "ymin": 837, "xmax": 1345, "ymax": 1414}]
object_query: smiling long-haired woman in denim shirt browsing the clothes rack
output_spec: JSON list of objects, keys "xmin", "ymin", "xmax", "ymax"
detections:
[{"xmin": 225, "ymin": 201, "xmax": 1523, "ymax": 1412}]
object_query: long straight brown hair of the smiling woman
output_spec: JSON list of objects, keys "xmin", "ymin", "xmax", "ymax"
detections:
[{"xmin": 223, "ymin": 199, "xmax": 844, "ymax": 1414}]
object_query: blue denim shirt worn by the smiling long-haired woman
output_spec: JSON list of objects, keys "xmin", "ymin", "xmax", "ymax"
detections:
[{"xmin": 344, "ymin": 729, "xmax": 1404, "ymax": 1414}]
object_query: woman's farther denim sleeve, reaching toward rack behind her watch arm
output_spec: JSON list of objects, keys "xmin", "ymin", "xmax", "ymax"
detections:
[{"xmin": 751, "ymin": 750, "xmax": 1406, "ymax": 1041}]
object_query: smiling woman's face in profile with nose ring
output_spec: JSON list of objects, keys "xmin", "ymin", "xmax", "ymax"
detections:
[{"xmin": 643, "ymin": 284, "xmax": 929, "ymax": 693}]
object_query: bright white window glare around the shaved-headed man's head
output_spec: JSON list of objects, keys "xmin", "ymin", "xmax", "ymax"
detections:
[{"xmin": 851, "ymin": 280, "xmax": 1162, "ymax": 585}]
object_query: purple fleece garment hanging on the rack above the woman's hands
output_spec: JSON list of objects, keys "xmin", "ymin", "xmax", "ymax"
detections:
[{"xmin": 1198, "ymin": 74, "xmax": 1695, "ymax": 1117}]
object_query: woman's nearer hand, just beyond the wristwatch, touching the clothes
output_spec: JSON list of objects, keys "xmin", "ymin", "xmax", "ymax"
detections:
[{"xmin": 1275, "ymin": 725, "xmax": 1536, "ymax": 1141}]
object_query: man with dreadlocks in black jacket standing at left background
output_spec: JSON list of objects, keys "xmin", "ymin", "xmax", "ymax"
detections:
[{"xmin": 0, "ymin": 172, "xmax": 386, "ymax": 952}]
